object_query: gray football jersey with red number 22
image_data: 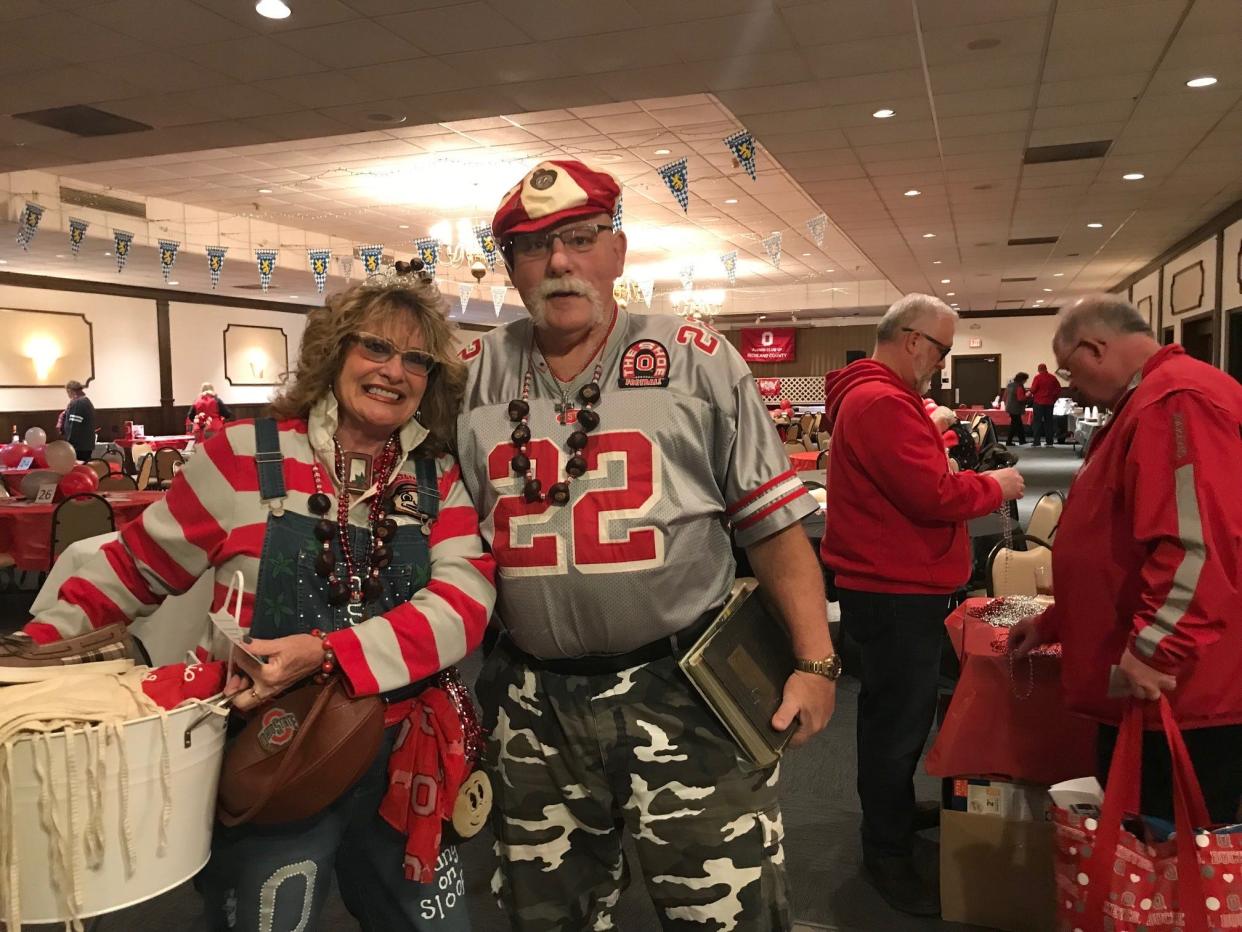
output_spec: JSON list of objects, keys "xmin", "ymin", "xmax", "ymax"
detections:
[{"xmin": 457, "ymin": 309, "xmax": 816, "ymax": 659}]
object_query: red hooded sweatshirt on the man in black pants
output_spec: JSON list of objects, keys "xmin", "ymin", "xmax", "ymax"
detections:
[{"xmin": 820, "ymin": 359, "xmax": 1002, "ymax": 594}]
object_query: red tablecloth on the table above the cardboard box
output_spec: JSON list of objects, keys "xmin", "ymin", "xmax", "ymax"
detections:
[{"xmin": 927, "ymin": 599, "xmax": 1095, "ymax": 784}]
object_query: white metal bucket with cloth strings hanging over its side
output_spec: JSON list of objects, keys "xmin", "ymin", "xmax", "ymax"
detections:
[{"xmin": 0, "ymin": 705, "xmax": 225, "ymax": 925}]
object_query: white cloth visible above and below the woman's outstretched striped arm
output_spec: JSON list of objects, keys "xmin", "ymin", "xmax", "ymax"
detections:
[{"xmin": 30, "ymin": 532, "xmax": 214, "ymax": 666}]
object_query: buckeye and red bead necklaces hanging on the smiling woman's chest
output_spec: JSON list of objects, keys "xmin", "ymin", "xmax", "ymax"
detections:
[{"xmin": 307, "ymin": 434, "xmax": 399, "ymax": 605}]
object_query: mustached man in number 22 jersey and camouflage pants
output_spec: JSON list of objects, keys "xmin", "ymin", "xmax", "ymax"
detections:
[{"xmin": 458, "ymin": 162, "xmax": 840, "ymax": 930}]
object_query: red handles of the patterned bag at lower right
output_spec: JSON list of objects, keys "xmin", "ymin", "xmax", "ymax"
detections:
[{"xmin": 1084, "ymin": 696, "xmax": 1211, "ymax": 932}]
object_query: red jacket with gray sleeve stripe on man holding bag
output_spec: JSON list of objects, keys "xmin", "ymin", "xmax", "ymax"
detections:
[{"xmin": 1033, "ymin": 345, "xmax": 1242, "ymax": 728}]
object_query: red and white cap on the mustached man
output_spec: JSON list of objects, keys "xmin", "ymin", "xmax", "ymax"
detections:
[{"xmin": 492, "ymin": 159, "xmax": 621, "ymax": 244}]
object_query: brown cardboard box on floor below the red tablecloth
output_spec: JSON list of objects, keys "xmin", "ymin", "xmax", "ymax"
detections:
[{"xmin": 940, "ymin": 810, "xmax": 1057, "ymax": 932}]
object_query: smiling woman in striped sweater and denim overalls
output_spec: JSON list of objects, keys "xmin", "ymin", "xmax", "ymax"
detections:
[{"xmin": 18, "ymin": 265, "xmax": 496, "ymax": 932}]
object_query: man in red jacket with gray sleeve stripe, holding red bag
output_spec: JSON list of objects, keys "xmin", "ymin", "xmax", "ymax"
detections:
[{"xmin": 1010, "ymin": 295, "xmax": 1242, "ymax": 823}]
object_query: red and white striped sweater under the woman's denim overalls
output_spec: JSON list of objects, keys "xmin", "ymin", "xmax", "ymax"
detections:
[{"xmin": 25, "ymin": 395, "xmax": 496, "ymax": 695}]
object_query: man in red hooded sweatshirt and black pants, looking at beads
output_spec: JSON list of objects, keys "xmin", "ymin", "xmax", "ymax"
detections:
[{"xmin": 820, "ymin": 295, "xmax": 1022, "ymax": 916}]
